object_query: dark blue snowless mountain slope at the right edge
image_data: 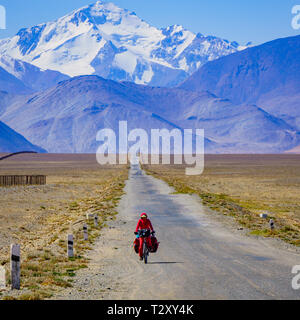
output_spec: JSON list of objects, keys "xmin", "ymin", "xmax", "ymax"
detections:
[{"xmin": 180, "ymin": 36, "xmax": 300, "ymax": 130}]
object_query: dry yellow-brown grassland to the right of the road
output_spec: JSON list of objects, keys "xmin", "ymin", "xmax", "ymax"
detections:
[{"xmin": 144, "ymin": 155, "xmax": 300, "ymax": 246}]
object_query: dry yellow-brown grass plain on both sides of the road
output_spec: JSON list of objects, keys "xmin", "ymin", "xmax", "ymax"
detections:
[{"xmin": 0, "ymin": 154, "xmax": 300, "ymax": 299}]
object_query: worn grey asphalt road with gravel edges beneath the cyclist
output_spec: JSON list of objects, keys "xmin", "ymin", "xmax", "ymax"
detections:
[{"xmin": 56, "ymin": 166, "xmax": 300, "ymax": 300}]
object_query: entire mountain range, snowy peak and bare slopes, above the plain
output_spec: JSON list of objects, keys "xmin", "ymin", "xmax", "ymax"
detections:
[{"xmin": 0, "ymin": 1, "xmax": 300, "ymax": 153}]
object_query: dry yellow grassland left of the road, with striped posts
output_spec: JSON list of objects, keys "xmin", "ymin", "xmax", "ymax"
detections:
[{"xmin": 0, "ymin": 155, "xmax": 128, "ymax": 300}]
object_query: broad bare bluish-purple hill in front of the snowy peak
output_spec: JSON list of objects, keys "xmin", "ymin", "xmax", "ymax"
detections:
[{"xmin": 1, "ymin": 76, "xmax": 300, "ymax": 153}]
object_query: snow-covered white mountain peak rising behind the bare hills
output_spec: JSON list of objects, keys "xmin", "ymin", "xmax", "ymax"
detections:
[{"xmin": 0, "ymin": 1, "xmax": 244, "ymax": 86}]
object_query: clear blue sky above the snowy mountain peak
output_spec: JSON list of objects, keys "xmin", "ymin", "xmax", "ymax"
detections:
[{"xmin": 0, "ymin": 0, "xmax": 300, "ymax": 44}]
